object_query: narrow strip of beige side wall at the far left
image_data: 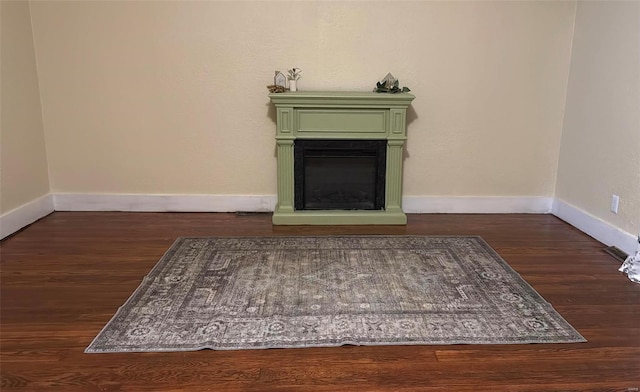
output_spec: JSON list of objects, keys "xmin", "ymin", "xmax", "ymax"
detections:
[{"xmin": 0, "ymin": 1, "xmax": 49, "ymax": 214}]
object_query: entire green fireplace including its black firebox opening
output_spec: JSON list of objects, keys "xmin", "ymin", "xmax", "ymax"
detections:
[{"xmin": 269, "ymin": 91, "xmax": 415, "ymax": 225}]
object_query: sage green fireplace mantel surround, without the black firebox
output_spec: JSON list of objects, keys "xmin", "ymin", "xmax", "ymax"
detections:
[{"xmin": 269, "ymin": 91, "xmax": 415, "ymax": 225}]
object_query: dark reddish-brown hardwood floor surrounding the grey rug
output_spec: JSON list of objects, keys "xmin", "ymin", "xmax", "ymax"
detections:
[{"xmin": 0, "ymin": 212, "xmax": 640, "ymax": 391}]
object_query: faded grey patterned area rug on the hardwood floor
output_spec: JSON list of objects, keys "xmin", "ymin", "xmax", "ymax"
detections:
[{"xmin": 85, "ymin": 236, "xmax": 585, "ymax": 353}]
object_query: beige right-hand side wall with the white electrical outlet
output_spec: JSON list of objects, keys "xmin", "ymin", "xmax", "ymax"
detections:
[{"xmin": 556, "ymin": 1, "xmax": 640, "ymax": 234}]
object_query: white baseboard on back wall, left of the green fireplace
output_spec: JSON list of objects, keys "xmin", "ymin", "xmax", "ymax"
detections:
[{"xmin": 54, "ymin": 193, "xmax": 276, "ymax": 212}]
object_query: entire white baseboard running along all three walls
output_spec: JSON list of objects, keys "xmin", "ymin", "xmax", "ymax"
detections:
[{"xmin": 6, "ymin": 193, "xmax": 637, "ymax": 254}]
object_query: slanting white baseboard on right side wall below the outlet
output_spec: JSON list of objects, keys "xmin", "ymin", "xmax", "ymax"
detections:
[{"xmin": 551, "ymin": 199, "xmax": 638, "ymax": 254}]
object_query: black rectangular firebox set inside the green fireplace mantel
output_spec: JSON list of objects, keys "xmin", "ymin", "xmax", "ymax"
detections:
[{"xmin": 294, "ymin": 139, "xmax": 387, "ymax": 210}]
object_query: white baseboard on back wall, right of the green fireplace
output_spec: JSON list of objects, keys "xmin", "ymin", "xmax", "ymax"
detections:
[{"xmin": 402, "ymin": 196, "xmax": 553, "ymax": 214}]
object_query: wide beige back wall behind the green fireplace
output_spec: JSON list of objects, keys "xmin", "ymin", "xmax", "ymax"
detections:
[{"xmin": 31, "ymin": 1, "xmax": 576, "ymax": 196}]
